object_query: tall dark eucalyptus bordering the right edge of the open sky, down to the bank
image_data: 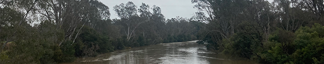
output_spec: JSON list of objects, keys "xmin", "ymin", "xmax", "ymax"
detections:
[{"xmin": 192, "ymin": 0, "xmax": 251, "ymax": 48}]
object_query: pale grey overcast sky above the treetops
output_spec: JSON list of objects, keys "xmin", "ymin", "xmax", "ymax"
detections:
[{"xmin": 99, "ymin": 0, "xmax": 273, "ymax": 19}]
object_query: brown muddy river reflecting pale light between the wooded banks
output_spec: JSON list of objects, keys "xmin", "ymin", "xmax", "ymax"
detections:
[{"xmin": 61, "ymin": 41, "xmax": 256, "ymax": 64}]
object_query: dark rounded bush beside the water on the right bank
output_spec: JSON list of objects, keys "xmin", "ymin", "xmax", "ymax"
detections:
[{"xmin": 223, "ymin": 23, "xmax": 262, "ymax": 58}]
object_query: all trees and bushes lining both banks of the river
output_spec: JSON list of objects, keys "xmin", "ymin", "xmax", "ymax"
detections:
[{"xmin": 0, "ymin": 0, "xmax": 324, "ymax": 64}]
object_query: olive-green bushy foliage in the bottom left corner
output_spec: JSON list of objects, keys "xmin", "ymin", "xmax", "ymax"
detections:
[{"xmin": 1, "ymin": 27, "xmax": 54, "ymax": 64}]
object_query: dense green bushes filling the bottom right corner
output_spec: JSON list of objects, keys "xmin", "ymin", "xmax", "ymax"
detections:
[{"xmin": 263, "ymin": 24, "xmax": 324, "ymax": 64}]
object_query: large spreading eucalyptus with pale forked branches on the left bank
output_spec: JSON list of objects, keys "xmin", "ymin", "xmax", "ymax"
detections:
[{"xmin": 30, "ymin": 0, "xmax": 110, "ymax": 45}]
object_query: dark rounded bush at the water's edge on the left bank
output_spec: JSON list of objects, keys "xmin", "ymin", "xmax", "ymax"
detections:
[{"xmin": 72, "ymin": 26, "xmax": 113, "ymax": 56}]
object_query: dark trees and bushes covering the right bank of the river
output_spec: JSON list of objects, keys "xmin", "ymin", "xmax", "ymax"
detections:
[{"xmin": 192, "ymin": 0, "xmax": 324, "ymax": 64}]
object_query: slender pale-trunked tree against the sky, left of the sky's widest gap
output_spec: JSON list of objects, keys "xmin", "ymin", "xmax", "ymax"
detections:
[{"xmin": 114, "ymin": 1, "xmax": 149, "ymax": 41}]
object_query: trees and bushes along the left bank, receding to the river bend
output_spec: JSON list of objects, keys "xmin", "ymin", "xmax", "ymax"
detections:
[{"xmin": 0, "ymin": 0, "xmax": 205, "ymax": 64}]
